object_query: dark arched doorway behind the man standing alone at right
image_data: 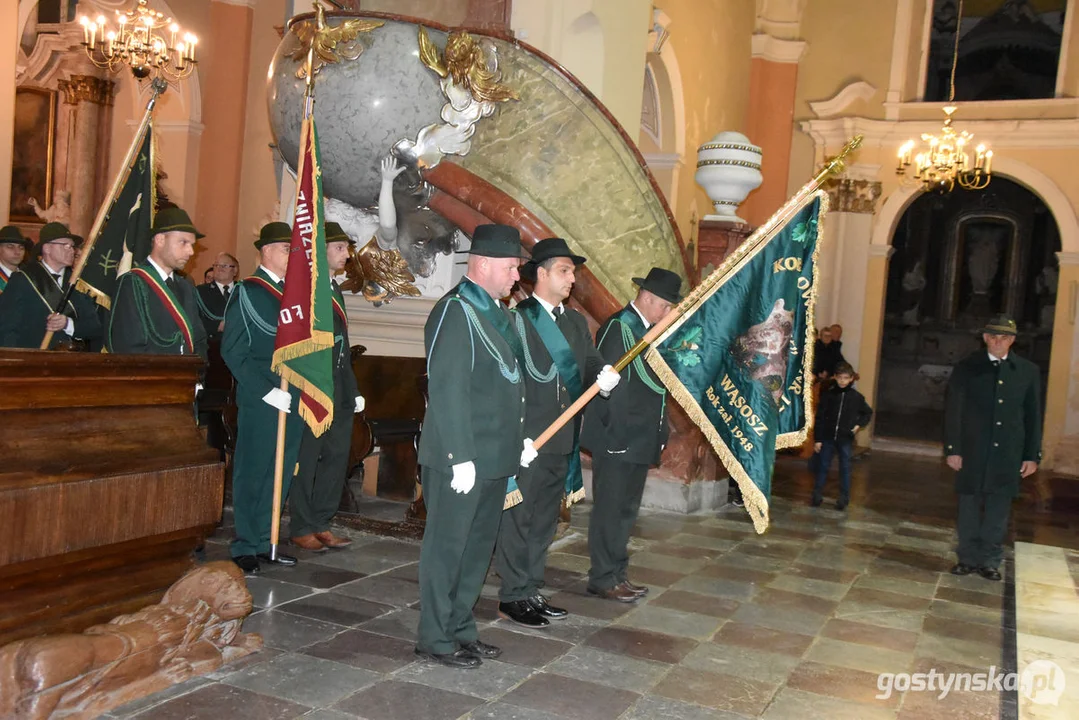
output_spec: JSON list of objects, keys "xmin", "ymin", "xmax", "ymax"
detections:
[{"xmin": 876, "ymin": 177, "xmax": 1061, "ymax": 443}]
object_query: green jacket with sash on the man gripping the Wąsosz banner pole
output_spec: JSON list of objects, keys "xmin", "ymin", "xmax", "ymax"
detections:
[{"xmin": 514, "ymin": 297, "xmax": 607, "ymax": 456}]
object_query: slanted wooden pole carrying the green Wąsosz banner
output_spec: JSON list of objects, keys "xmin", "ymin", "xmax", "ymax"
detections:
[{"xmin": 532, "ymin": 135, "xmax": 862, "ymax": 450}]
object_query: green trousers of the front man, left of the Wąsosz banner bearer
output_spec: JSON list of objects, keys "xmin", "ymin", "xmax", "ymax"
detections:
[{"xmin": 415, "ymin": 466, "xmax": 506, "ymax": 655}]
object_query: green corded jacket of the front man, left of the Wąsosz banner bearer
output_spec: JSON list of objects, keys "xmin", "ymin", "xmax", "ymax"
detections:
[{"xmin": 420, "ymin": 279, "xmax": 525, "ymax": 480}]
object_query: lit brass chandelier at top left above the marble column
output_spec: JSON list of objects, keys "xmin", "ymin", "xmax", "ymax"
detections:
[{"xmin": 79, "ymin": 0, "xmax": 199, "ymax": 81}]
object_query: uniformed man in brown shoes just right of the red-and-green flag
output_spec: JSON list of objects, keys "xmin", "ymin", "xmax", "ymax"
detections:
[{"xmin": 288, "ymin": 222, "xmax": 364, "ymax": 553}]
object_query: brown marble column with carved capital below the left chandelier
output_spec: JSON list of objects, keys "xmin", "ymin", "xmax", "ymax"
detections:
[{"xmin": 57, "ymin": 74, "xmax": 114, "ymax": 236}]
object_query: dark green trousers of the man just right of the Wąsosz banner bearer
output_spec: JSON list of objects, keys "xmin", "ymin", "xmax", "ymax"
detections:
[{"xmin": 588, "ymin": 452, "xmax": 648, "ymax": 589}]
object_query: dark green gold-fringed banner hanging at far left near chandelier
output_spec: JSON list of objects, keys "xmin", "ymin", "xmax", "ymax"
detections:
[{"xmin": 78, "ymin": 125, "xmax": 154, "ymax": 308}]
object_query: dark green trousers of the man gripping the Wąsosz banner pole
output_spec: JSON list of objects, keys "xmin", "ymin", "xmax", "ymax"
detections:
[{"xmin": 495, "ymin": 454, "xmax": 570, "ymax": 602}]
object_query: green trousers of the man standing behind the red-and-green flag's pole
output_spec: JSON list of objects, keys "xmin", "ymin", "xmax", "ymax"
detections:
[{"xmin": 229, "ymin": 400, "xmax": 304, "ymax": 557}]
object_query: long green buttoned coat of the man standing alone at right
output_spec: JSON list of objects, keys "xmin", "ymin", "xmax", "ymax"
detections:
[{"xmin": 944, "ymin": 350, "xmax": 1041, "ymax": 497}]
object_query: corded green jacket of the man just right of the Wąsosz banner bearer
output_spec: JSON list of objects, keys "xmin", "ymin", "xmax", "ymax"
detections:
[{"xmin": 581, "ymin": 304, "xmax": 669, "ymax": 465}]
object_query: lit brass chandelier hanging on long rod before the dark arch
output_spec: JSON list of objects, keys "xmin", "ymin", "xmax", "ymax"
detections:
[{"xmin": 896, "ymin": 0, "xmax": 993, "ymax": 192}]
